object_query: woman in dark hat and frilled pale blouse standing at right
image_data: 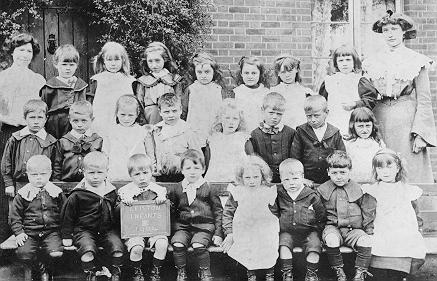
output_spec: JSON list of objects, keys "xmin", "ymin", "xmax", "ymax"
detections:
[{"xmin": 363, "ymin": 11, "xmax": 437, "ymax": 183}]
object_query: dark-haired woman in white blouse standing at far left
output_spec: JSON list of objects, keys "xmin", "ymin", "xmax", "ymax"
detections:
[{"xmin": 0, "ymin": 33, "xmax": 46, "ymax": 243}]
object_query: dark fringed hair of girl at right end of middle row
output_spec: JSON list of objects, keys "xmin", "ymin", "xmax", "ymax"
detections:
[{"xmin": 347, "ymin": 107, "xmax": 381, "ymax": 144}]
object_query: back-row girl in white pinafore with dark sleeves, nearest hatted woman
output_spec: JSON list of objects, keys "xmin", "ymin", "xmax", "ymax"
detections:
[{"xmin": 319, "ymin": 46, "xmax": 378, "ymax": 135}]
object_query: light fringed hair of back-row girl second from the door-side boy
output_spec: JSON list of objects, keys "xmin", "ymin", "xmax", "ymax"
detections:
[{"xmin": 93, "ymin": 41, "xmax": 130, "ymax": 75}]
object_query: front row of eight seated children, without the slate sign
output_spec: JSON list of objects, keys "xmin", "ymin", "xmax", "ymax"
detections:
[{"xmin": 10, "ymin": 149, "xmax": 425, "ymax": 281}]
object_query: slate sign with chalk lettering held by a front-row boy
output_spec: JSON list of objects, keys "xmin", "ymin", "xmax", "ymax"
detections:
[{"xmin": 120, "ymin": 200, "xmax": 170, "ymax": 239}]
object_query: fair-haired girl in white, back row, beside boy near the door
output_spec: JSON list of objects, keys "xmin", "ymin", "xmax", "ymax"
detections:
[{"xmin": 90, "ymin": 42, "xmax": 135, "ymax": 136}]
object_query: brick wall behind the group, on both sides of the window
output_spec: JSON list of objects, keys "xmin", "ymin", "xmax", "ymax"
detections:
[{"xmin": 205, "ymin": 0, "xmax": 437, "ymax": 179}]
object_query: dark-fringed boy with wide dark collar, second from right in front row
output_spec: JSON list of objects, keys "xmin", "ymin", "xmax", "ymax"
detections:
[{"xmin": 317, "ymin": 150, "xmax": 372, "ymax": 281}]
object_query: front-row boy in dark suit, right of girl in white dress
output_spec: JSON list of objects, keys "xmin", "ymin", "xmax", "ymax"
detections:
[{"xmin": 272, "ymin": 158, "xmax": 326, "ymax": 281}]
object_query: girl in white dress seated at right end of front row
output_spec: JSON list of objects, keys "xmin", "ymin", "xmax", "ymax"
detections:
[{"xmin": 362, "ymin": 149, "xmax": 426, "ymax": 281}]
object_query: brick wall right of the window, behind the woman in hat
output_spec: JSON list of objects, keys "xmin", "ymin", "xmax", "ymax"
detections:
[{"xmin": 404, "ymin": 0, "xmax": 437, "ymax": 179}]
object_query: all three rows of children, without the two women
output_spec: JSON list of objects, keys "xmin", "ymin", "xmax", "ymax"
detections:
[{"xmin": 1, "ymin": 34, "xmax": 424, "ymax": 281}]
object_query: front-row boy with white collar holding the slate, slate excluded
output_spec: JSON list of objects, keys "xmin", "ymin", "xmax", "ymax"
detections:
[{"xmin": 118, "ymin": 154, "xmax": 168, "ymax": 281}]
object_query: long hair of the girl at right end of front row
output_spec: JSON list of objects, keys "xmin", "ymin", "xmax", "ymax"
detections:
[{"xmin": 372, "ymin": 148, "xmax": 407, "ymax": 182}]
